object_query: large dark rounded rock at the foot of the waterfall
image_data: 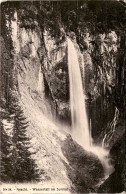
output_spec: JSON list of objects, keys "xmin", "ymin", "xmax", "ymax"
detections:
[{"xmin": 62, "ymin": 136, "xmax": 104, "ymax": 193}]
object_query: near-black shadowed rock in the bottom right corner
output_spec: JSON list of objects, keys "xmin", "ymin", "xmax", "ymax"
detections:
[{"xmin": 98, "ymin": 134, "xmax": 126, "ymax": 193}]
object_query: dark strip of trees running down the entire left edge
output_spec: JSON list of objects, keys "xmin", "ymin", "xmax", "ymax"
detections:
[{"xmin": 0, "ymin": 3, "xmax": 39, "ymax": 183}]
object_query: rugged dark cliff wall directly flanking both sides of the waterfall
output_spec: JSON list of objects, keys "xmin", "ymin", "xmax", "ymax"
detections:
[{"xmin": 43, "ymin": 26, "xmax": 125, "ymax": 150}]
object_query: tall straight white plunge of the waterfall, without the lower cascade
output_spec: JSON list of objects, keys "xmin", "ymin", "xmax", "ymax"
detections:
[{"xmin": 68, "ymin": 39, "xmax": 91, "ymax": 148}]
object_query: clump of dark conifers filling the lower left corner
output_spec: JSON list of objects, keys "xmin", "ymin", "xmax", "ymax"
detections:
[{"xmin": 1, "ymin": 96, "xmax": 39, "ymax": 182}]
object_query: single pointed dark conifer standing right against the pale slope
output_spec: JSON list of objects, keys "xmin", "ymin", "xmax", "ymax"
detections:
[{"xmin": 13, "ymin": 106, "xmax": 39, "ymax": 182}]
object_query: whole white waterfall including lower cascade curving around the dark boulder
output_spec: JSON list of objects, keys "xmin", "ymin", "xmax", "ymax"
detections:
[{"xmin": 67, "ymin": 38, "xmax": 114, "ymax": 178}]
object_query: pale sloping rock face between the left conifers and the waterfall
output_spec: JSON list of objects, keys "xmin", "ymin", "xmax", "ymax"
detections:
[{"xmin": 4, "ymin": 9, "xmax": 70, "ymax": 188}]
